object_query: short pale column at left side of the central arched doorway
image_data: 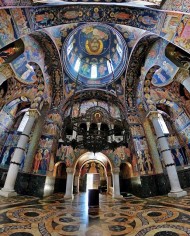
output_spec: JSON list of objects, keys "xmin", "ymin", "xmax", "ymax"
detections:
[{"xmin": 64, "ymin": 167, "xmax": 74, "ymax": 199}]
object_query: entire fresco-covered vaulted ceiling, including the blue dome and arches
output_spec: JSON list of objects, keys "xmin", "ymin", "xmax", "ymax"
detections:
[{"xmin": 0, "ymin": 0, "xmax": 190, "ymax": 188}]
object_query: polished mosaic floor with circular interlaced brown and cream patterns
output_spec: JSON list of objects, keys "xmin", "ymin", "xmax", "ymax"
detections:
[{"xmin": 0, "ymin": 191, "xmax": 190, "ymax": 236}]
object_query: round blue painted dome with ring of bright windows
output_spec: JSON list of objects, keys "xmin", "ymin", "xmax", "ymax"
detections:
[{"xmin": 62, "ymin": 23, "xmax": 128, "ymax": 87}]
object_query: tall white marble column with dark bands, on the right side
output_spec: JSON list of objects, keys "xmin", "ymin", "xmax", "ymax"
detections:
[{"xmin": 148, "ymin": 112, "xmax": 187, "ymax": 197}]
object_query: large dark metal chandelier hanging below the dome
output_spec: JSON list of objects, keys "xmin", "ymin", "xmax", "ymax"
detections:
[{"xmin": 62, "ymin": 58, "xmax": 129, "ymax": 153}]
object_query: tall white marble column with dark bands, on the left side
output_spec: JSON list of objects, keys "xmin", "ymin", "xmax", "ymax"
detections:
[{"xmin": 0, "ymin": 109, "xmax": 39, "ymax": 197}]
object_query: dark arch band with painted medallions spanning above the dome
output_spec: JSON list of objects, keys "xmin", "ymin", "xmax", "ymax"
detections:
[{"xmin": 24, "ymin": 4, "xmax": 186, "ymax": 53}]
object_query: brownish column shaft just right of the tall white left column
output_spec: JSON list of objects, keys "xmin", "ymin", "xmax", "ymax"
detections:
[{"xmin": 23, "ymin": 106, "xmax": 47, "ymax": 173}]
